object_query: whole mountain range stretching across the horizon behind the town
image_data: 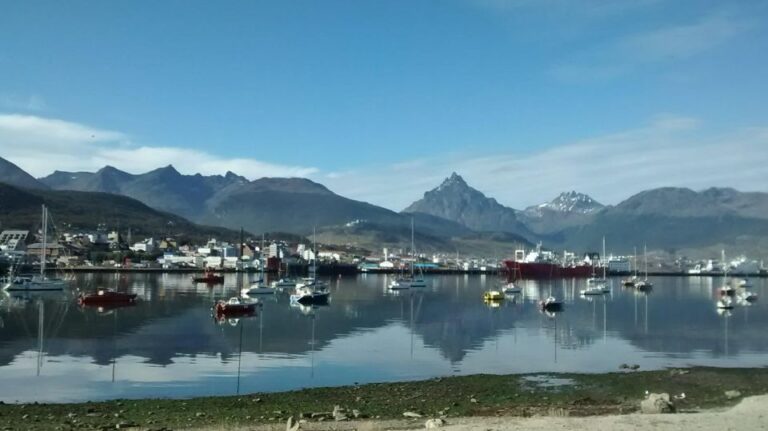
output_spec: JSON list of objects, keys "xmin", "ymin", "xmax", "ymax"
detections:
[{"xmin": 0, "ymin": 159, "xmax": 768, "ymax": 254}]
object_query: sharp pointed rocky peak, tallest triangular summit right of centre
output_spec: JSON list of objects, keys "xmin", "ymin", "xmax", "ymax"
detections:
[{"xmin": 402, "ymin": 172, "xmax": 534, "ymax": 238}]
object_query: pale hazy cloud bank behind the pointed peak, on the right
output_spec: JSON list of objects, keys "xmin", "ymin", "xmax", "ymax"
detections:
[{"xmin": 316, "ymin": 115, "xmax": 768, "ymax": 210}]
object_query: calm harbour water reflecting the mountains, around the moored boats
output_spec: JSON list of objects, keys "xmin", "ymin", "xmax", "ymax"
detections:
[{"xmin": 0, "ymin": 274, "xmax": 768, "ymax": 402}]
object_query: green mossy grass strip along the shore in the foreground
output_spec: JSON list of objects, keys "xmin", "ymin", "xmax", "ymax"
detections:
[{"xmin": 0, "ymin": 368, "xmax": 768, "ymax": 430}]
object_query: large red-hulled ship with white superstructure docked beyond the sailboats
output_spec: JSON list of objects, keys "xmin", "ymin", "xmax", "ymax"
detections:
[{"xmin": 504, "ymin": 244, "xmax": 596, "ymax": 279}]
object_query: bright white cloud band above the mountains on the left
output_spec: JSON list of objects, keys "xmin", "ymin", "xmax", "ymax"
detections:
[{"xmin": 0, "ymin": 114, "xmax": 317, "ymax": 179}]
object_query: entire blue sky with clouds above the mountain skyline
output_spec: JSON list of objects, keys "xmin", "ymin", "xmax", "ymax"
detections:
[{"xmin": 0, "ymin": 0, "xmax": 768, "ymax": 210}]
